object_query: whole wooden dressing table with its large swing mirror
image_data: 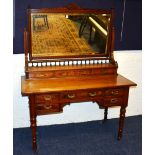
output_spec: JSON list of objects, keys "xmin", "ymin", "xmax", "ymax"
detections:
[{"xmin": 21, "ymin": 4, "xmax": 136, "ymax": 151}]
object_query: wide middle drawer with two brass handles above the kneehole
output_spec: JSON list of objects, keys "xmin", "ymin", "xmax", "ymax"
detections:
[{"xmin": 61, "ymin": 90, "xmax": 103, "ymax": 102}]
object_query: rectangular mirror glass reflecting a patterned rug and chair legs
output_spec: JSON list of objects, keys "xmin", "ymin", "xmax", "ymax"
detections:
[{"xmin": 31, "ymin": 13, "xmax": 110, "ymax": 57}]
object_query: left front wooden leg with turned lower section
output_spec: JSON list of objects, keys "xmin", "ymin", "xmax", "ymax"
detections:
[{"xmin": 29, "ymin": 95, "xmax": 37, "ymax": 151}]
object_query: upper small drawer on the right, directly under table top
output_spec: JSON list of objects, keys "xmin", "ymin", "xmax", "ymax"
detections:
[{"xmin": 104, "ymin": 88, "xmax": 124, "ymax": 96}]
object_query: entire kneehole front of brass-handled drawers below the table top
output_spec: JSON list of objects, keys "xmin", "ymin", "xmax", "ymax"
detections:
[{"xmin": 35, "ymin": 88, "xmax": 125, "ymax": 112}]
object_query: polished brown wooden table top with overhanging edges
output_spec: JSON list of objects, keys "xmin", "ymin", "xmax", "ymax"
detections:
[{"xmin": 21, "ymin": 74, "xmax": 136, "ymax": 95}]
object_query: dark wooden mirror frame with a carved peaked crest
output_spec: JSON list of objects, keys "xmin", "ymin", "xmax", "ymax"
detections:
[{"xmin": 27, "ymin": 4, "xmax": 114, "ymax": 61}]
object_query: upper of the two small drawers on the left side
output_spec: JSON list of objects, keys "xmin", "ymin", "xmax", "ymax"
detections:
[{"xmin": 35, "ymin": 94, "xmax": 59, "ymax": 104}]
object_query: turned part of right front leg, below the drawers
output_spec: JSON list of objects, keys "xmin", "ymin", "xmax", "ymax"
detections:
[{"xmin": 117, "ymin": 106, "xmax": 126, "ymax": 140}]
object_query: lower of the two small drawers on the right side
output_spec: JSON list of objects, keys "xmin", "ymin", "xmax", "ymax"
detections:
[{"xmin": 103, "ymin": 97, "xmax": 123, "ymax": 106}]
